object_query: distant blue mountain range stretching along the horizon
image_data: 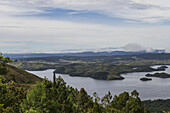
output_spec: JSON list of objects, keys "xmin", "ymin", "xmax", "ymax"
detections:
[{"xmin": 3, "ymin": 50, "xmax": 165, "ymax": 59}]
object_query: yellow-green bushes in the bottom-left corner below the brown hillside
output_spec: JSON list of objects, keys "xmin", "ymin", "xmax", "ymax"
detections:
[{"xmin": 0, "ymin": 77, "xmax": 25, "ymax": 113}]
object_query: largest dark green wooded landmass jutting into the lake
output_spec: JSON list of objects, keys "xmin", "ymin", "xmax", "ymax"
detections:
[{"xmin": 54, "ymin": 63, "xmax": 166, "ymax": 80}]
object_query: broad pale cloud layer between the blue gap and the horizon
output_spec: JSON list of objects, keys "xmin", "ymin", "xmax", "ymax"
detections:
[{"xmin": 0, "ymin": 13, "xmax": 170, "ymax": 51}]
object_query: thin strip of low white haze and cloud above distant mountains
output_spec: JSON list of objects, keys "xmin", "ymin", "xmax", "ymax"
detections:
[{"xmin": 3, "ymin": 43, "xmax": 170, "ymax": 54}]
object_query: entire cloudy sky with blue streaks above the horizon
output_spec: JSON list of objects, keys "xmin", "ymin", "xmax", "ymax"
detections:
[{"xmin": 0, "ymin": 0, "xmax": 170, "ymax": 53}]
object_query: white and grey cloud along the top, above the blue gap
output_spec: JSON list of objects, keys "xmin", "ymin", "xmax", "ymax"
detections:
[{"xmin": 0, "ymin": 0, "xmax": 170, "ymax": 23}]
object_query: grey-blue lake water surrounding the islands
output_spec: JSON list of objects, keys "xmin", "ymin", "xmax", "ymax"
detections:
[{"xmin": 28, "ymin": 66, "xmax": 170, "ymax": 100}]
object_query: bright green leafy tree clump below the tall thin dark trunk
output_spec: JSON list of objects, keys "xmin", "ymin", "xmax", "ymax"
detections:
[{"xmin": 21, "ymin": 77, "xmax": 78, "ymax": 113}]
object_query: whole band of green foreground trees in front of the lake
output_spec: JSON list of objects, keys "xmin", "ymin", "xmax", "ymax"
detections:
[{"xmin": 0, "ymin": 77, "xmax": 149, "ymax": 113}]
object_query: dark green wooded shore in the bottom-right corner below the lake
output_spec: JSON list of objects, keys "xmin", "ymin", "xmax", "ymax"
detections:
[{"xmin": 142, "ymin": 99, "xmax": 170, "ymax": 113}]
